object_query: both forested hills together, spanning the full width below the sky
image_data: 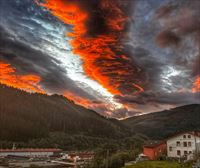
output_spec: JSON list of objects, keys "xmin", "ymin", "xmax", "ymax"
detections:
[{"xmin": 0, "ymin": 85, "xmax": 200, "ymax": 150}]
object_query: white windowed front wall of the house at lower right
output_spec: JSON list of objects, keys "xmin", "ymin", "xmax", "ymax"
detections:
[{"xmin": 167, "ymin": 133, "xmax": 200, "ymax": 158}]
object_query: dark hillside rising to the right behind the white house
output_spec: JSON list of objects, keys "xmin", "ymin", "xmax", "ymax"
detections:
[{"xmin": 122, "ymin": 104, "xmax": 200, "ymax": 139}]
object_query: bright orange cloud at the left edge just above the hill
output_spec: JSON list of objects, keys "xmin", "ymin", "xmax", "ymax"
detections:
[{"xmin": 0, "ymin": 62, "xmax": 45, "ymax": 93}]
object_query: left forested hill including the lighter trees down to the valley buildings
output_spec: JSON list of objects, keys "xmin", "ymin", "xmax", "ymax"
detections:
[{"xmin": 0, "ymin": 85, "xmax": 145, "ymax": 150}]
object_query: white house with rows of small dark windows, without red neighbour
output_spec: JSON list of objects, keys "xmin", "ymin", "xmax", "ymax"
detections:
[{"xmin": 166, "ymin": 132, "xmax": 200, "ymax": 160}]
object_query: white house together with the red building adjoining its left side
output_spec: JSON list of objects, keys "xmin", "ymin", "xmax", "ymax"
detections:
[{"xmin": 143, "ymin": 132, "xmax": 200, "ymax": 160}]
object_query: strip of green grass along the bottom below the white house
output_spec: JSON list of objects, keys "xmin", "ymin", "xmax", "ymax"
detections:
[{"xmin": 124, "ymin": 161, "xmax": 192, "ymax": 168}]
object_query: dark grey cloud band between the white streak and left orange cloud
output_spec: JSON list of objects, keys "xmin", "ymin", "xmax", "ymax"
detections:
[{"xmin": 0, "ymin": 27, "xmax": 97, "ymax": 99}]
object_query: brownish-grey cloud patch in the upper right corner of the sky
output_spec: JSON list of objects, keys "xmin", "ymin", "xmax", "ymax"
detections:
[{"xmin": 156, "ymin": 0, "xmax": 200, "ymax": 77}]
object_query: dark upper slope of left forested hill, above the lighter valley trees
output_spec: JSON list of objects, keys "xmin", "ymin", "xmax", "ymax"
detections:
[{"xmin": 0, "ymin": 85, "xmax": 130, "ymax": 146}]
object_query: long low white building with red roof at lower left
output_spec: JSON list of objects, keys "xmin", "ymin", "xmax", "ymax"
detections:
[{"xmin": 0, "ymin": 148, "xmax": 61, "ymax": 157}]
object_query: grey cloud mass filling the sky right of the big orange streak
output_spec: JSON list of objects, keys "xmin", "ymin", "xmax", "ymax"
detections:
[{"xmin": 110, "ymin": 0, "xmax": 200, "ymax": 115}]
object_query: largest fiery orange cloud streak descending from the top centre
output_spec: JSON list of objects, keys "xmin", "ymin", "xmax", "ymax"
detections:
[{"xmin": 37, "ymin": 0, "xmax": 144, "ymax": 94}]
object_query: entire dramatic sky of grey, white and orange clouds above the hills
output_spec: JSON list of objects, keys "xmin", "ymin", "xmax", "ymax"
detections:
[{"xmin": 0, "ymin": 0, "xmax": 200, "ymax": 118}]
